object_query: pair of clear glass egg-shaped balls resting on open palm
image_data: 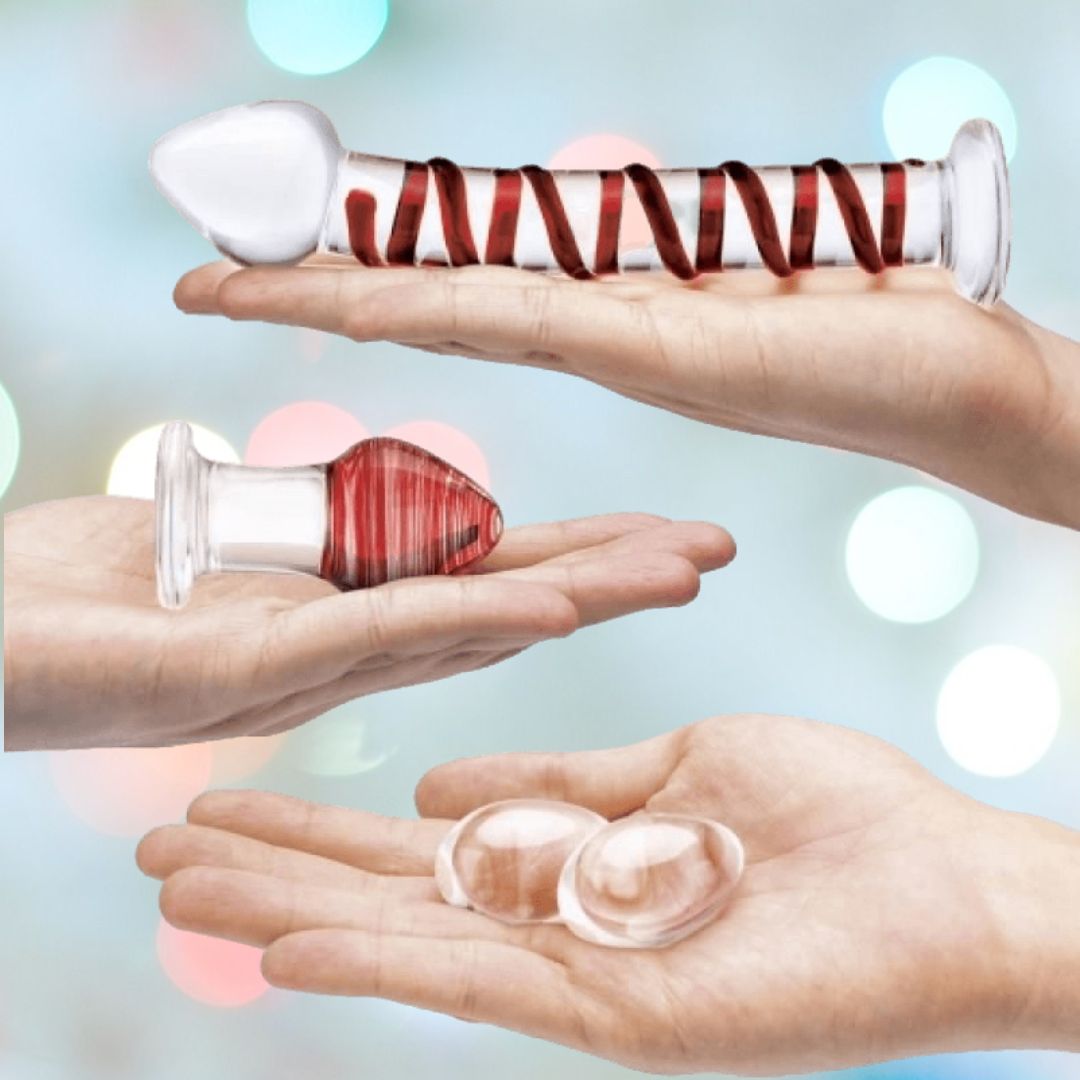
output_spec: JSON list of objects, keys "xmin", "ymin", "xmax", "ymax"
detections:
[{"xmin": 435, "ymin": 799, "xmax": 745, "ymax": 948}]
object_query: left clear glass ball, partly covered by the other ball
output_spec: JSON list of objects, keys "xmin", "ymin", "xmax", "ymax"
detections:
[{"xmin": 435, "ymin": 799, "xmax": 607, "ymax": 922}]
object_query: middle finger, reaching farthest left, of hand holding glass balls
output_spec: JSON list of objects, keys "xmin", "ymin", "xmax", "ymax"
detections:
[{"xmin": 135, "ymin": 825, "xmax": 437, "ymax": 900}]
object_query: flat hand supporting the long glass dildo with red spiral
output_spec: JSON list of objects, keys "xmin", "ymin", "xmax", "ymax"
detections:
[{"xmin": 176, "ymin": 257, "xmax": 1080, "ymax": 528}]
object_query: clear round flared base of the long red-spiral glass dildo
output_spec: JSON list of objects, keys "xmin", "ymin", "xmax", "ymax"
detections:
[{"xmin": 944, "ymin": 120, "xmax": 1012, "ymax": 307}]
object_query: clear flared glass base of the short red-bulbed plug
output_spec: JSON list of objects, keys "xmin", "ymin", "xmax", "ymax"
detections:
[{"xmin": 154, "ymin": 420, "xmax": 203, "ymax": 610}]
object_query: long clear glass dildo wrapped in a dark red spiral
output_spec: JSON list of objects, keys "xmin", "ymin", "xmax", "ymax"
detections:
[{"xmin": 150, "ymin": 102, "xmax": 1010, "ymax": 305}]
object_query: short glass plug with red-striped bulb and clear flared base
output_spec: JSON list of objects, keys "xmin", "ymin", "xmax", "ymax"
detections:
[{"xmin": 156, "ymin": 422, "xmax": 502, "ymax": 608}]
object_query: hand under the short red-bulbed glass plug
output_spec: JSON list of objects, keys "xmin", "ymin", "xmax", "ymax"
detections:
[{"xmin": 3, "ymin": 497, "xmax": 734, "ymax": 750}]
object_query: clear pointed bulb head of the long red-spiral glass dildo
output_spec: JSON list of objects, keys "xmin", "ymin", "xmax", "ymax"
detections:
[{"xmin": 150, "ymin": 102, "xmax": 345, "ymax": 265}]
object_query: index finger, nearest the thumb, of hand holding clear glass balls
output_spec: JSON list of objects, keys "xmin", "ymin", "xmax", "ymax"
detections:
[{"xmin": 188, "ymin": 791, "xmax": 451, "ymax": 875}]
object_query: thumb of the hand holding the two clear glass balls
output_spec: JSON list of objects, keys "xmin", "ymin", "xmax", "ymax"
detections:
[{"xmin": 416, "ymin": 728, "xmax": 688, "ymax": 819}]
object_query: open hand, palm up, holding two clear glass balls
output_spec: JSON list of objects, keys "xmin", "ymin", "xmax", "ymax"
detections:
[{"xmin": 138, "ymin": 716, "xmax": 1080, "ymax": 1075}]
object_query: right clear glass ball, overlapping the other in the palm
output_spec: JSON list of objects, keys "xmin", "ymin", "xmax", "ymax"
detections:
[{"xmin": 558, "ymin": 813, "xmax": 743, "ymax": 948}]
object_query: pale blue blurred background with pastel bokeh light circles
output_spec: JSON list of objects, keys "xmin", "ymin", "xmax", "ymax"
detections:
[{"xmin": 0, "ymin": 0, "xmax": 1080, "ymax": 1080}]
